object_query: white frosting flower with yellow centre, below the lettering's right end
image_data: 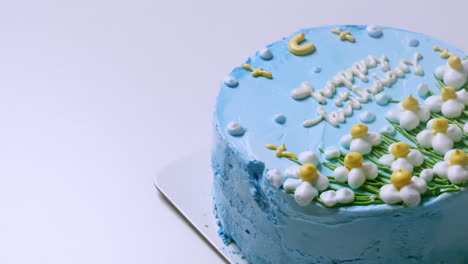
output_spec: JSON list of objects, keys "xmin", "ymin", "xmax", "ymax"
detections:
[{"xmin": 385, "ymin": 95, "xmax": 431, "ymax": 130}]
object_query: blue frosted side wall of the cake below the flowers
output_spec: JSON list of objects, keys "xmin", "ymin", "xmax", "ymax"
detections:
[{"xmin": 213, "ymin": 124, "xmax": 468, "ymax": 264}]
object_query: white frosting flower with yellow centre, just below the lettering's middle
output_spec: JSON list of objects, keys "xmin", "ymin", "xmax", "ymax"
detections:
[{"xmin": 340, "ymin": 123, "xmax": 382, "ymax": 155}]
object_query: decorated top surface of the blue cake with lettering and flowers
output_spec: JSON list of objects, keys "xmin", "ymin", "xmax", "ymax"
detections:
[{"xmin": 215, "ymin": 25, "xmax": 468, "ymax": 210}]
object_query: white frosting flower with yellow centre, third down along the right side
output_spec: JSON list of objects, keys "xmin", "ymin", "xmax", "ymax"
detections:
[{"xmin": 416, "ymin": 118, "xmax": 463, "ymax": 155}]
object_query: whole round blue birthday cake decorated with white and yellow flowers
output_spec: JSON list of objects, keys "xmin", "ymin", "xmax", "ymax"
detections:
[{"xmin": 212, "ymin": 25, "xmax": 468, "ymax": 264}]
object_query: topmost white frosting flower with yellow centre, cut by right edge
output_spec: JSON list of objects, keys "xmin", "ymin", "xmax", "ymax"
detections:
[{"xmin": 434, "ymin": 55, "xmax": 468, "ymax": 90}]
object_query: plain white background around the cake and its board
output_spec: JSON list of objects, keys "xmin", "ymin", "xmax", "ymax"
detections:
[{"xmin": 0, "ymin": 0, "xmax": 468, "ymax": 264}]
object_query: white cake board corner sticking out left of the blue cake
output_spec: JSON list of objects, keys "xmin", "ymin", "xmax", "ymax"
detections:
[{"xmin": 155, "ymin": 150, "xmax": 248, "ymax": 264}]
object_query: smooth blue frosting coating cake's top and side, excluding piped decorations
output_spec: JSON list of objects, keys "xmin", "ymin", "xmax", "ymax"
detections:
[{"xmin": 212, "ymin": 26, "xmax": 468, "ymax": 263}]
